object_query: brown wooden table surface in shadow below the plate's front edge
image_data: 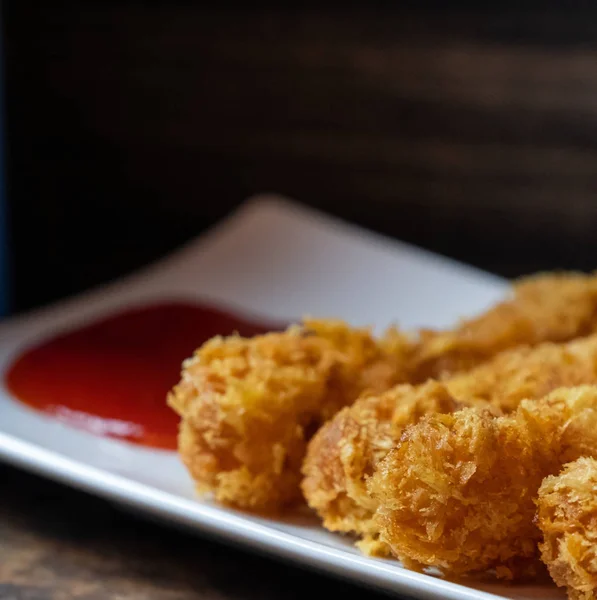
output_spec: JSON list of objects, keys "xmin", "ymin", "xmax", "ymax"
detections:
[{"xmin": 0, "ymin": 466, "xmax": 392, "ymax": 600}]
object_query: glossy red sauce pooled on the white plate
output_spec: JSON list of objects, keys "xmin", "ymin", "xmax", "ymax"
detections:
[{"xmin": 6, "ymin": 302, "xmax": 279, "ymax": 449}]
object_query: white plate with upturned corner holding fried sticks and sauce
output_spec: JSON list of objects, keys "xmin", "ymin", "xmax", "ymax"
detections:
[{"xmin": 0, "ymin": 196, "xmax": 562, "ymax": 600}]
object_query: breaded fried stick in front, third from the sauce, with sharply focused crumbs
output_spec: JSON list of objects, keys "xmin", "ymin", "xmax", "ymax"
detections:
[{"xmin": 369, "ymin": 386, "xmax": 597, "ymax": 578}]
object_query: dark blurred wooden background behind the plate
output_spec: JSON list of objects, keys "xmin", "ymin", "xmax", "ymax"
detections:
[{"xmin": 0, "ymin": 0, "xmax": 597, "ymax": 312}]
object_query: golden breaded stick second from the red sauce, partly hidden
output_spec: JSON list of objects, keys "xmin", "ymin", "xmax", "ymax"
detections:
[{"xmin": 302, "ymin": 335, "xmax": 597, "ymax": 553}]
